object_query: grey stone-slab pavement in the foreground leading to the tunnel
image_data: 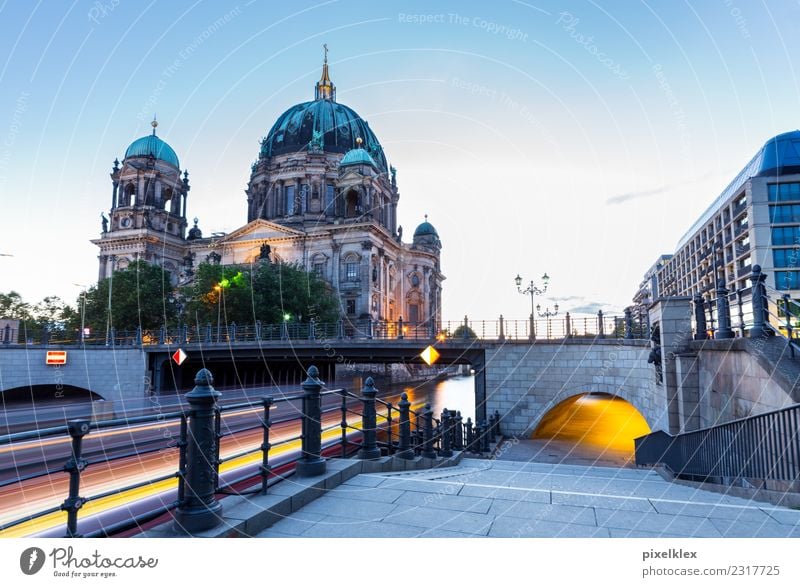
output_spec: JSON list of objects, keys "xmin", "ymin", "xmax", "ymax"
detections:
[{"xmin": 258, "ymin": 459, "xmax": 800, "ymax": 538}]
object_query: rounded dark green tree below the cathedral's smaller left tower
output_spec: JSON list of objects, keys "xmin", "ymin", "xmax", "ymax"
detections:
[{"xmin": 78, "ymin": 261, "xmax": 178, "ymax": 333}]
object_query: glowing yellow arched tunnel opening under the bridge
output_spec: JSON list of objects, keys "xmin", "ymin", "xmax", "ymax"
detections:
[{"xmin": 531, "ymin": 392, "xmax": 650, "ymax": 461}]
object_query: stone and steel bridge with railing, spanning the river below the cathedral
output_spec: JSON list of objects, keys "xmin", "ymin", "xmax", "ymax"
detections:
[{"xmin": 0, "ymin": 290, "xmax": 800, "ymax": 437}]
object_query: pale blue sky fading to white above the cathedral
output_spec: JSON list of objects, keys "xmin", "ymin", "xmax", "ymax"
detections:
[{"xmin": 0, "ymin": 0, "xmax": 800, "ymax": 319}]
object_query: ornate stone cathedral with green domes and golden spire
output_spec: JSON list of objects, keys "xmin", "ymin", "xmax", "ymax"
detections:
[{"xmin": 92, "ymin": 49, "xmax": 444, "ymax": 332}]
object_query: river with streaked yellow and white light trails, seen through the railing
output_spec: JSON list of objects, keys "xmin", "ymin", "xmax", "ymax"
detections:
[{"xmin": 0, "ymin": 378, "xmax": 474, "ymax": 536}]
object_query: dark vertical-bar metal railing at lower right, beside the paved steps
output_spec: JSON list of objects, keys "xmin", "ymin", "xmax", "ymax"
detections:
[{"xmin": 635, "ymin": 404, "xmax": 800, "ymax": 490}]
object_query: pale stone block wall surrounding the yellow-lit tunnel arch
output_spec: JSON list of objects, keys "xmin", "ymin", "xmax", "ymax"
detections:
[{"xmin": 485, "ymin": 339, "xmax": 668, "ymax": 436}]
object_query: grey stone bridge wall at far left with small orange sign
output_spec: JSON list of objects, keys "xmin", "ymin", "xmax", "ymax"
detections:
[{"xmin": 0, "ymin": 346, "xmax": 150, "ymax": 401}]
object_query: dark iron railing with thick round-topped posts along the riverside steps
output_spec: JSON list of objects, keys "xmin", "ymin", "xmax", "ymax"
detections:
[{"xmin": 0, "ymin": 366, "xmax": 490, "ymax": 537}]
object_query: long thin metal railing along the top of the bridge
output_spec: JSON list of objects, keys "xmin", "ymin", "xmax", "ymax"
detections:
[{"xmin": 0, "ymin": 312, "xmax": 649, "ymax": 348}]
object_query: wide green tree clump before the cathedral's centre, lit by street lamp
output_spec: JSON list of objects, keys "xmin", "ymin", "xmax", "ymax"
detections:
[{"xmin": 181, "ymin": 262, "xmax": 339, "ymax": 326}]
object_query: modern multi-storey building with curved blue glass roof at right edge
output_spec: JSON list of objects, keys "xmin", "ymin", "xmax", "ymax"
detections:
[{"xmin": 634, "ymin": 131, "xmax": 800, "ymax": 303}]
